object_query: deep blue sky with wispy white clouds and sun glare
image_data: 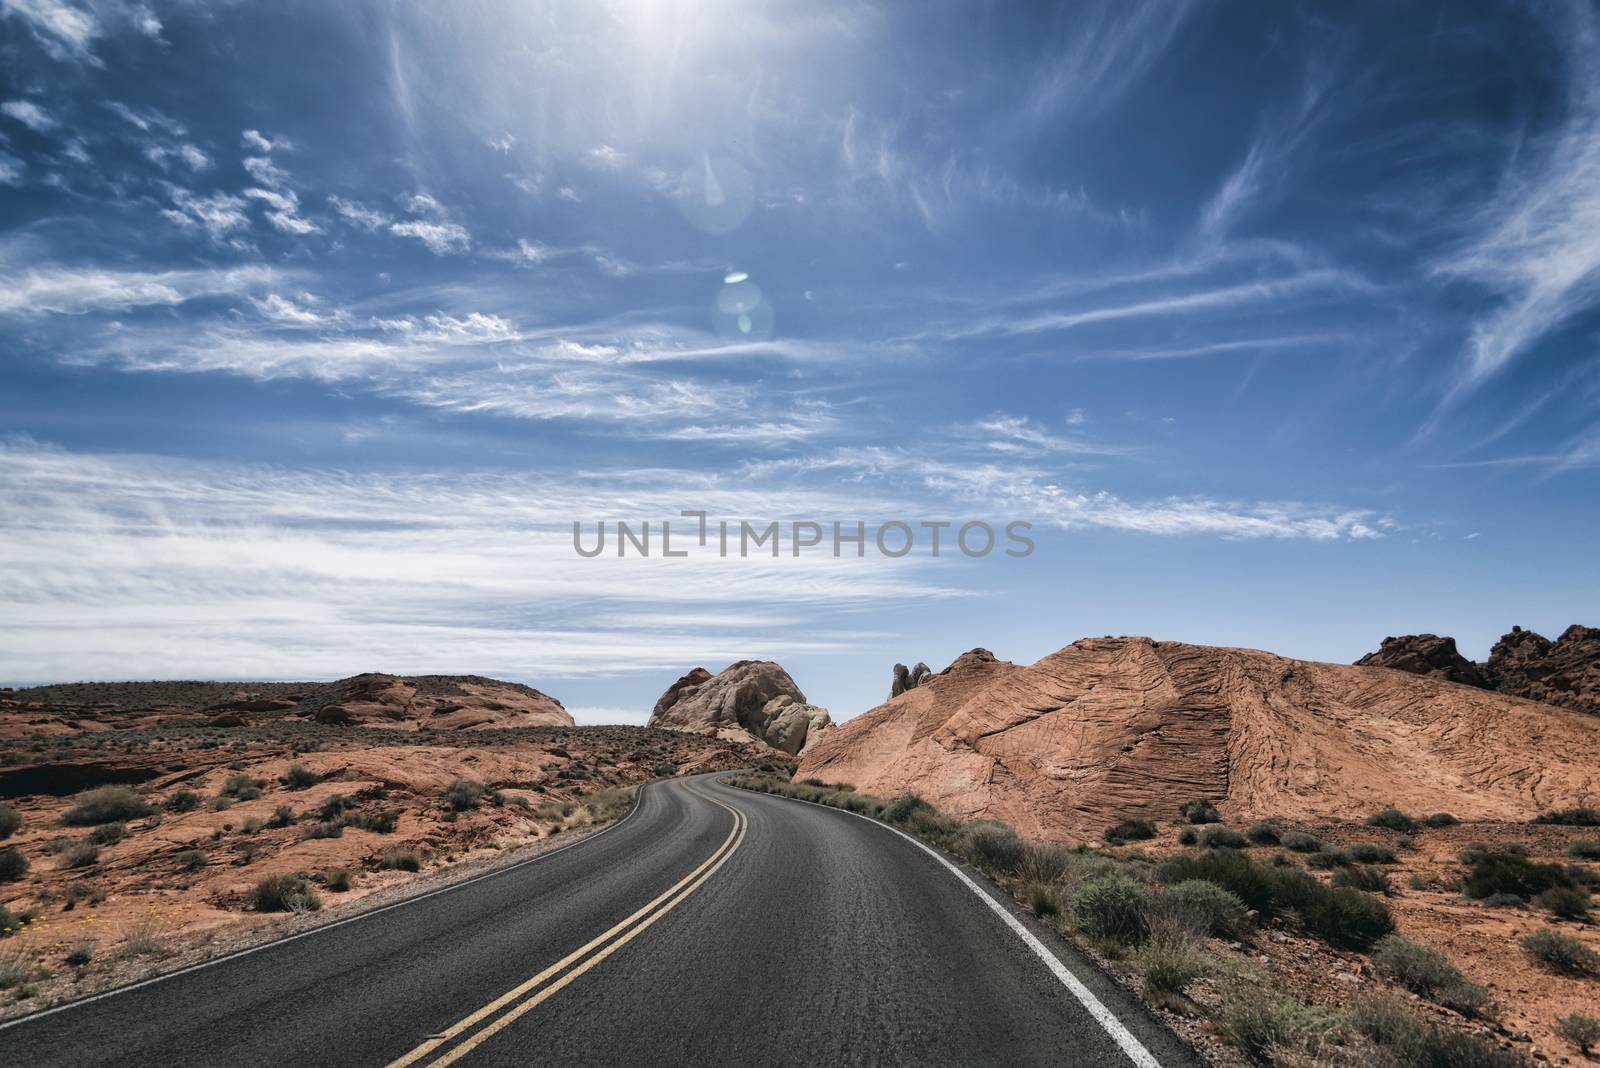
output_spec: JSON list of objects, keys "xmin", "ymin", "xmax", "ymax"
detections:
[{"xmin": 0, "ymin": 0, "xmax": 1600, "ymax": 721}]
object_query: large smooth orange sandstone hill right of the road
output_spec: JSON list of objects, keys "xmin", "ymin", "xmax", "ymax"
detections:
[{"xmin": 797, "ymin": 638, "xmax": 1600, "ymax": 841}]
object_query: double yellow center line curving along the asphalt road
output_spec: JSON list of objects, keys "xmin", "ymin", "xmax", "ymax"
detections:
[{"xmin": 387, "ymin": 785, "xmax": 749, "ymax": 1068}]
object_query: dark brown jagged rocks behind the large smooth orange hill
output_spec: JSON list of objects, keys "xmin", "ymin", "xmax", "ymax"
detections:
[{"xmin": 1355, "ymin": 624, "xmax": 1600, "ymax": 715}]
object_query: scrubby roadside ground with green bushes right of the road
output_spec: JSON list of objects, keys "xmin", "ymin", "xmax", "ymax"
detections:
[{"xmin": 730, "ymin": 766, "xmax": 1600, "ymax": 1068}]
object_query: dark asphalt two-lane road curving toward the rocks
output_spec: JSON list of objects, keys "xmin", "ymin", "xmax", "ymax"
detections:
[{"xmin": 0, "ymin": 777, "xmax": 1198, "ymax": 1068}]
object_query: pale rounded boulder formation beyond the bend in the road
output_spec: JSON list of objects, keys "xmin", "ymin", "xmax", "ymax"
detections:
[{"xmin": 650, "ymin": 660, "xmax": 834, "ymax": 756}]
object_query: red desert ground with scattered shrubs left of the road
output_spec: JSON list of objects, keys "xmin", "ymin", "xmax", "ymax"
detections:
[{"xmin": 0, "ymin": 675, "xmax": 755, "ymax": 1015}]
